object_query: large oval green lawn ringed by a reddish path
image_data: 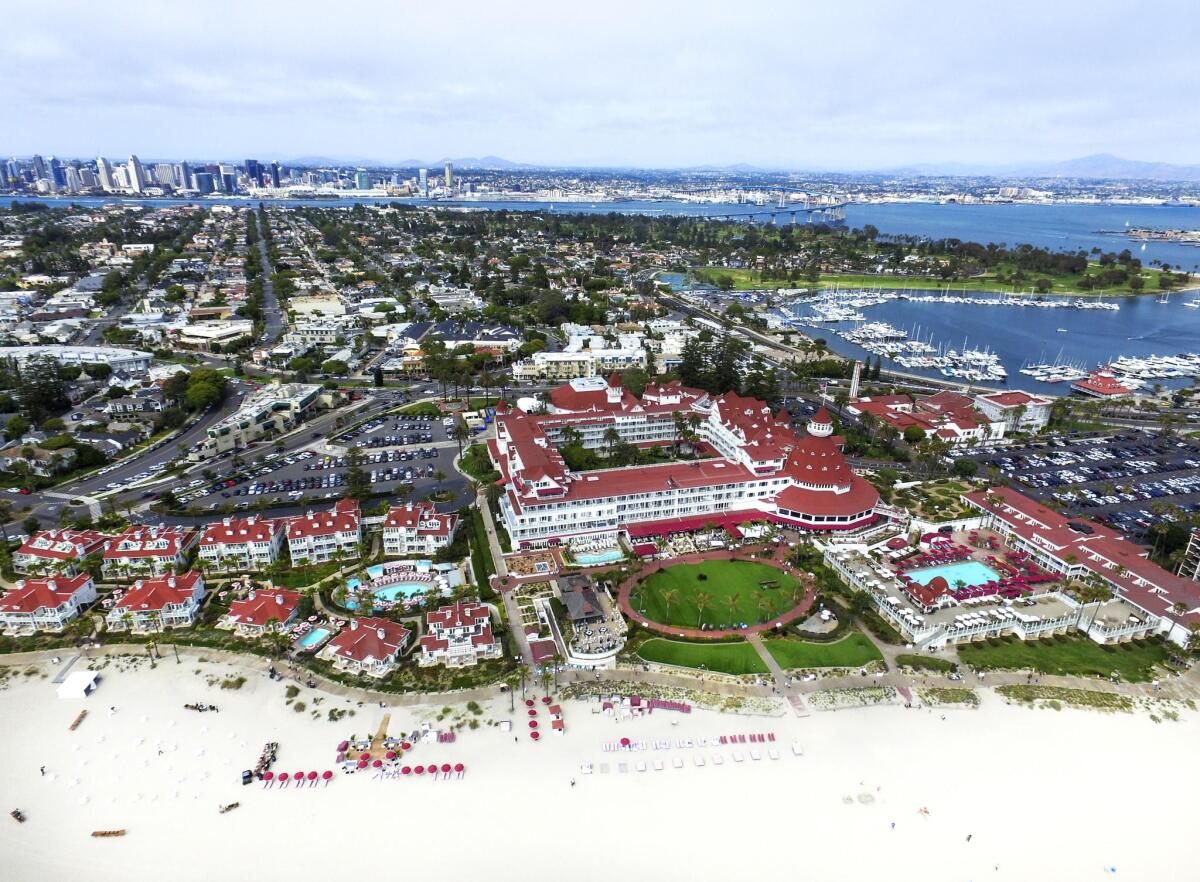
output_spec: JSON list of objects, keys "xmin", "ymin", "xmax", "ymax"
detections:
[{"xmin": 630, "ymin": 560, "xmax": 803, "ymax": 628}]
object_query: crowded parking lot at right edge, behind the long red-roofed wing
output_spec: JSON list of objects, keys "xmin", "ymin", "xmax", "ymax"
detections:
[{"xmin": 973, "ymin": 433, "xmax": 1200, "ymax": 535}]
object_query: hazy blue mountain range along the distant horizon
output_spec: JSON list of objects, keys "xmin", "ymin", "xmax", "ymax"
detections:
[{"xmin": 283, "ymin": 154, "xmax": 1200, "ymax": 181}]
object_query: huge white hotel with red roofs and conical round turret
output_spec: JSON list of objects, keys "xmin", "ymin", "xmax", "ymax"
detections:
[{"xmin": 488, "ymin": 376, "xmax": 878, "ymax": 547}]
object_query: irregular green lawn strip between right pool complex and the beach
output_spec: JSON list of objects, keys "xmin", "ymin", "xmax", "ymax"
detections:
[{"xmin": 959, "ymin": 637, "xmax": 1166, "ymax": 683}]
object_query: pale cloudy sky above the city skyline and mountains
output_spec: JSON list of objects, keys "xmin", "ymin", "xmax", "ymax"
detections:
[{"xmin": 0, "ymin": 0, "xmax": 1200, "ymax": 170}]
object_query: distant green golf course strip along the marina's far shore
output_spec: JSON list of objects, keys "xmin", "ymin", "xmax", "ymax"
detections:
[{"xmin": 695, "ymin": 264, "xmax": 1176, "ymax": 296}]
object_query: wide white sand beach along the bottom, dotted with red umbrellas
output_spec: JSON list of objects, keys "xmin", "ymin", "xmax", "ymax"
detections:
[{"xmin": 0, "ymin": 660, "xmax": 1200, "ymax": 882}]
